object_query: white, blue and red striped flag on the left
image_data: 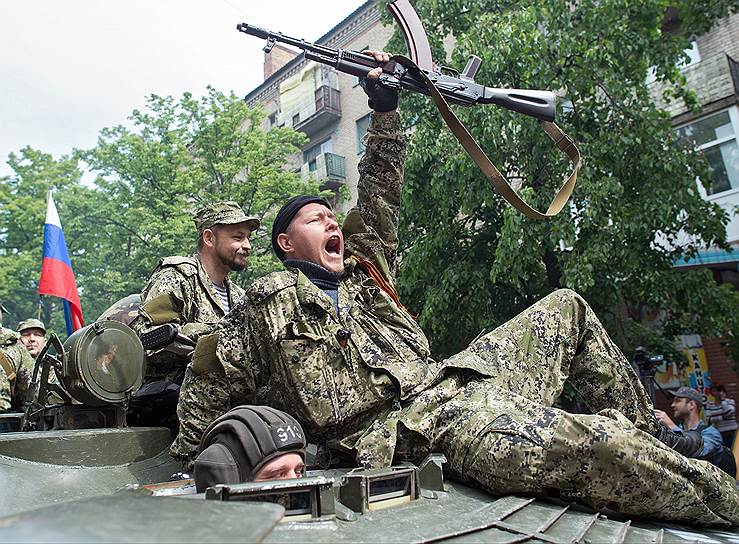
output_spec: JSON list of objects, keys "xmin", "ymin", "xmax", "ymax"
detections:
[{"xmin": 38, "ymin": 191, "xmax": 84, "ymax": 335}]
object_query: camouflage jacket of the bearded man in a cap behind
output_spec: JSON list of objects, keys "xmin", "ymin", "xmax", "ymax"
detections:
[{"xmin": 130, "ymin": 254, "xmax": 244, "ymax": 383}]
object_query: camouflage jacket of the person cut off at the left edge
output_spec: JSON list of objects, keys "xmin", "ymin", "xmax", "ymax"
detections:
[{"xmin": 0, "ymin": 327, "xmax": 34, "ymax": 413}]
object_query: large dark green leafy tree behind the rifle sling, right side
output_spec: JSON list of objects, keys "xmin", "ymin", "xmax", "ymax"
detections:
[{"xmin": 389, "ymin": 0, "xmax": 739, "ymax": 364}]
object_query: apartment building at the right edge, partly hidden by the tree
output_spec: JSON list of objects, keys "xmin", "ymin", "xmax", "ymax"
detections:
[{"xmin": 653, "ymin": 14, "xmax": 739, "ymax": 399}]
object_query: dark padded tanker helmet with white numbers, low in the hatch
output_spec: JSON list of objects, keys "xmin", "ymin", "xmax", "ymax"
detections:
[{"xmin": 194, "ymin": 406, "xmax": 306, "ymax": 493}]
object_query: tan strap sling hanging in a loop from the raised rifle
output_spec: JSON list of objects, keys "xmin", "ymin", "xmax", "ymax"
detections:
[{"xmin": 393, "ymin": 55, "xmax": 582, "ymax": 219}]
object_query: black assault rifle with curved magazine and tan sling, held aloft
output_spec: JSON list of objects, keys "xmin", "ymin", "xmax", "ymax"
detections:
[{"xmin": 236, "ymin": 0, "xmax": 581, "ymax": 219}]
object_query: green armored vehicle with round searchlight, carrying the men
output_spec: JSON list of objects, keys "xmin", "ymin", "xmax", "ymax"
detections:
[{"xmin": 0, "ymin": 320, "xmax": 739, "ymax": 542}]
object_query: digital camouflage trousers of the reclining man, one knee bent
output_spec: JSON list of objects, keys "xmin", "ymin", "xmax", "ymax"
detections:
[{"xmin": 388, "ymin": 290, "xmax": 739, "ymax": 525}]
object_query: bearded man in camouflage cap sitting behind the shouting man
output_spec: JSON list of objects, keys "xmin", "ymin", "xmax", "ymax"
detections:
[{"xmin": 131, "ymin": 201, "xmax": 259, "ymax": 384}]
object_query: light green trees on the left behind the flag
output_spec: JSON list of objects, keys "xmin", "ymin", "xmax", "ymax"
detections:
[{"xmin": 0, "ymin": 88, "xmax": 326, "ymax": 330}]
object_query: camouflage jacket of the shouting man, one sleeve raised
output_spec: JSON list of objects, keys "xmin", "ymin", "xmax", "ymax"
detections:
[{"xmin": 171, "ymin": 112, "xmax": 498, "ymax": 468}]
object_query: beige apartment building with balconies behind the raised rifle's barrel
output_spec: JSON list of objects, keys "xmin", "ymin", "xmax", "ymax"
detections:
[{"xmin": 244, "ymin": 0, "xmax": 393, "ymax": 211}]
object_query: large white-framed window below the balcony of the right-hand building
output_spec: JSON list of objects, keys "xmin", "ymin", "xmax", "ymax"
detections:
[{"xmin": 677, "ymin": 107, "xmax": 739, "ymax": 195}]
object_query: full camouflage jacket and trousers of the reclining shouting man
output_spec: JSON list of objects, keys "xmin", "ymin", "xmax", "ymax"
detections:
[{"xmin": 171, "ymin": 112, "xmax": 739, "ymax": 525}]
